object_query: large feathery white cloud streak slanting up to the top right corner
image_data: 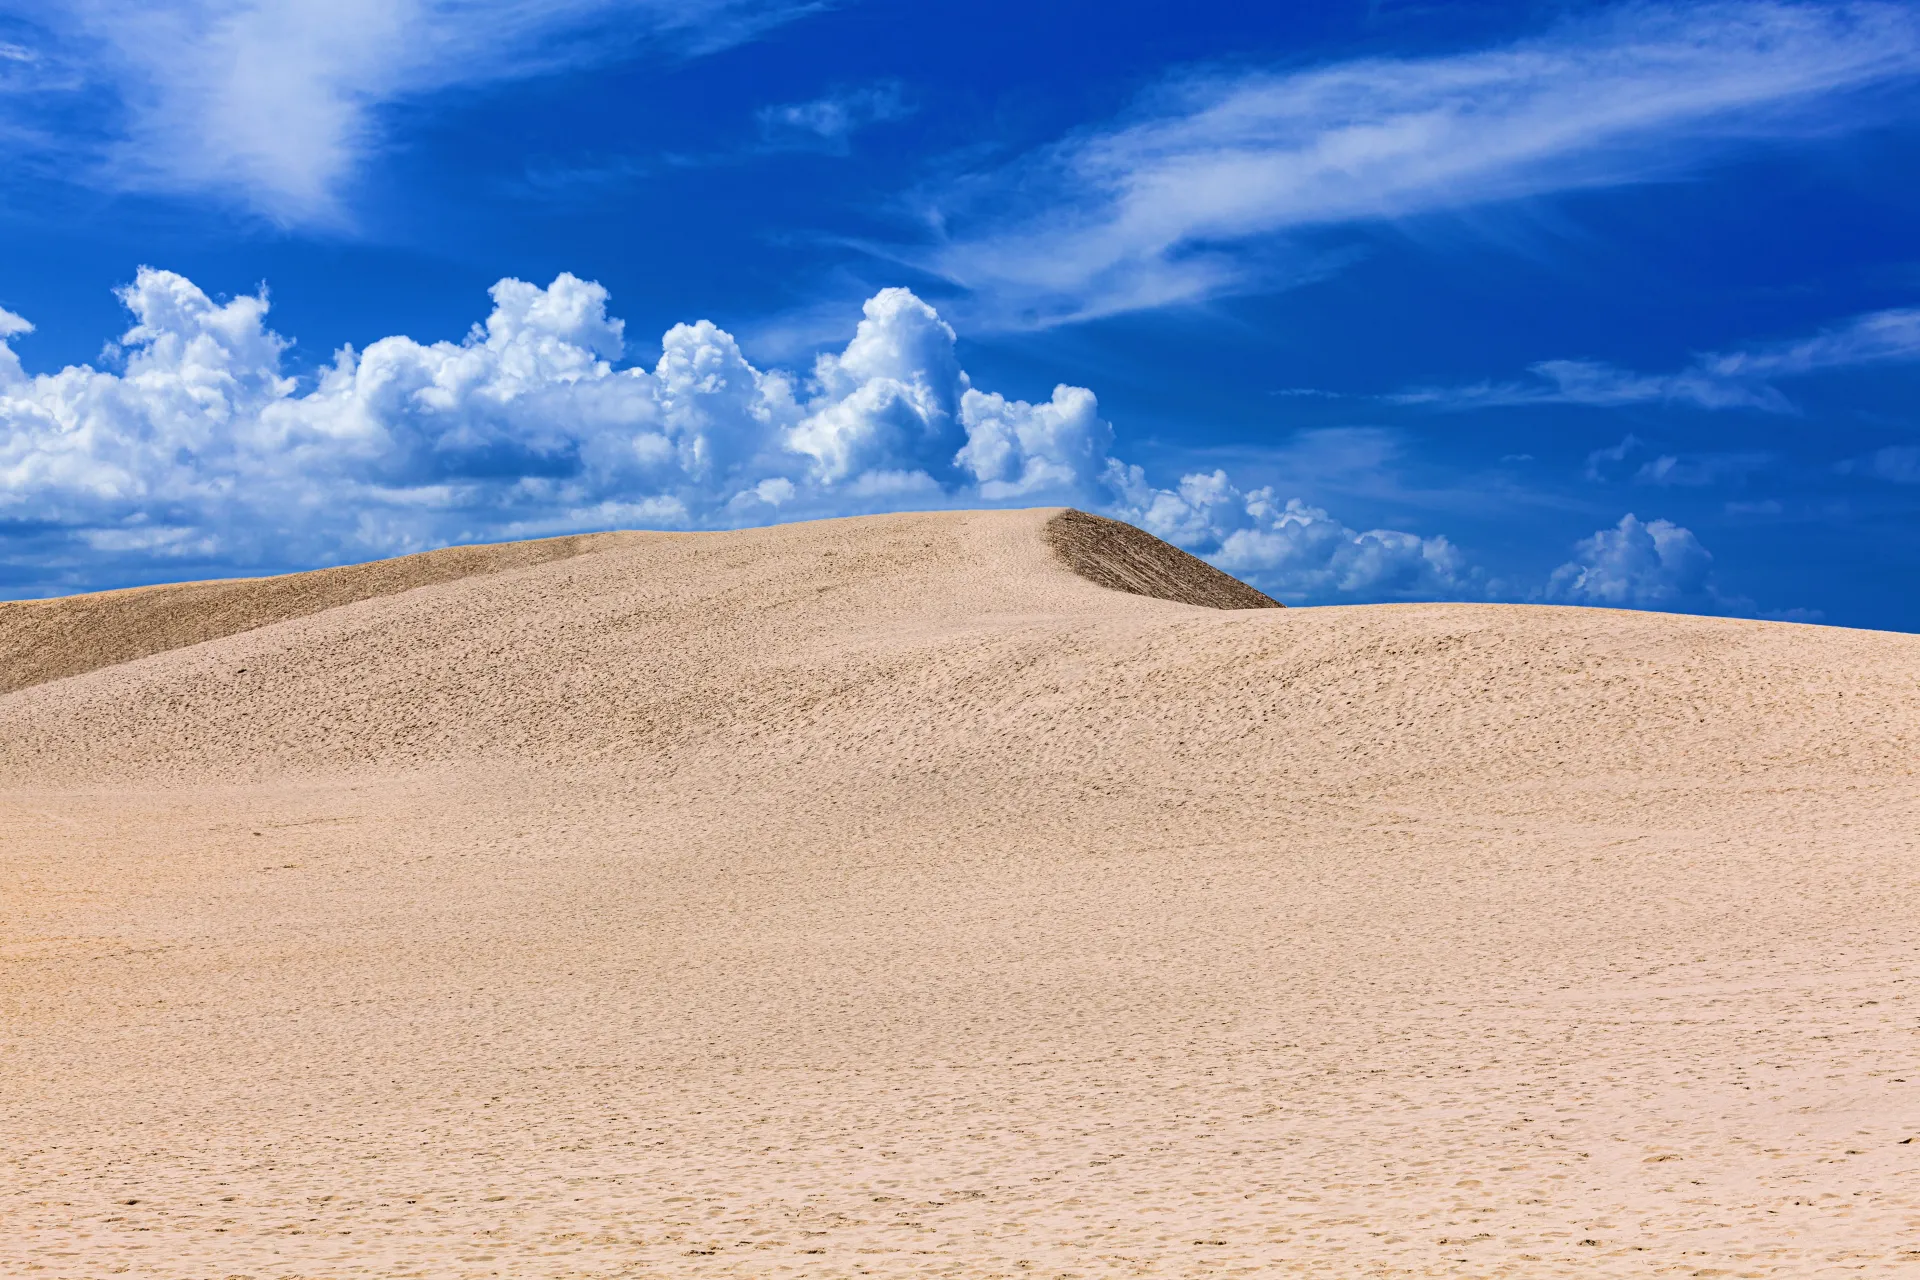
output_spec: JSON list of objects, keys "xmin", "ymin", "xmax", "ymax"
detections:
[{"xmin": 916, "ymin": 2, "xmax": 1920, "ymax": 324}]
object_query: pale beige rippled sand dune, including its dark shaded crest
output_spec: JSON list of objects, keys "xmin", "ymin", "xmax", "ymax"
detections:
[{"xmin": 0, "ymin": 510, "xmax": 1920, "ymax": 1280}]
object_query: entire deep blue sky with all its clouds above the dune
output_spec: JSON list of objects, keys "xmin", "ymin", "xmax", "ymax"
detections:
[{"xmin": 0, "ymin": 0, "xmax": 1920, "ymax": 629}]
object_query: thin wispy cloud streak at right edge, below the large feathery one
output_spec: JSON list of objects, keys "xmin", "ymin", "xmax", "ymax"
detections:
[{"xmin": 1386, "ymin": 307, "xmax": 1920, "ymax": 413}]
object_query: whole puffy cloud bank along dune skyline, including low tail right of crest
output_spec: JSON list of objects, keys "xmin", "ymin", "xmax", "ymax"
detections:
[{"xmin": 0, "ymin": 269, "xmax": 1488, "ymax": 599}]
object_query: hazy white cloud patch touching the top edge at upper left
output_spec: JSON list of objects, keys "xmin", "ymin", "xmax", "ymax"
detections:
[{"xmin": 3, "ymin": 0, "xmax": 804, "ymax": 225}]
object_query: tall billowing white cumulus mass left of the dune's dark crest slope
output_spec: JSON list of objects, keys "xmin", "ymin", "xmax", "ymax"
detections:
[{"xmin": 0, "ymin": 269, "xmax": 1082, "ymax": 549}]
